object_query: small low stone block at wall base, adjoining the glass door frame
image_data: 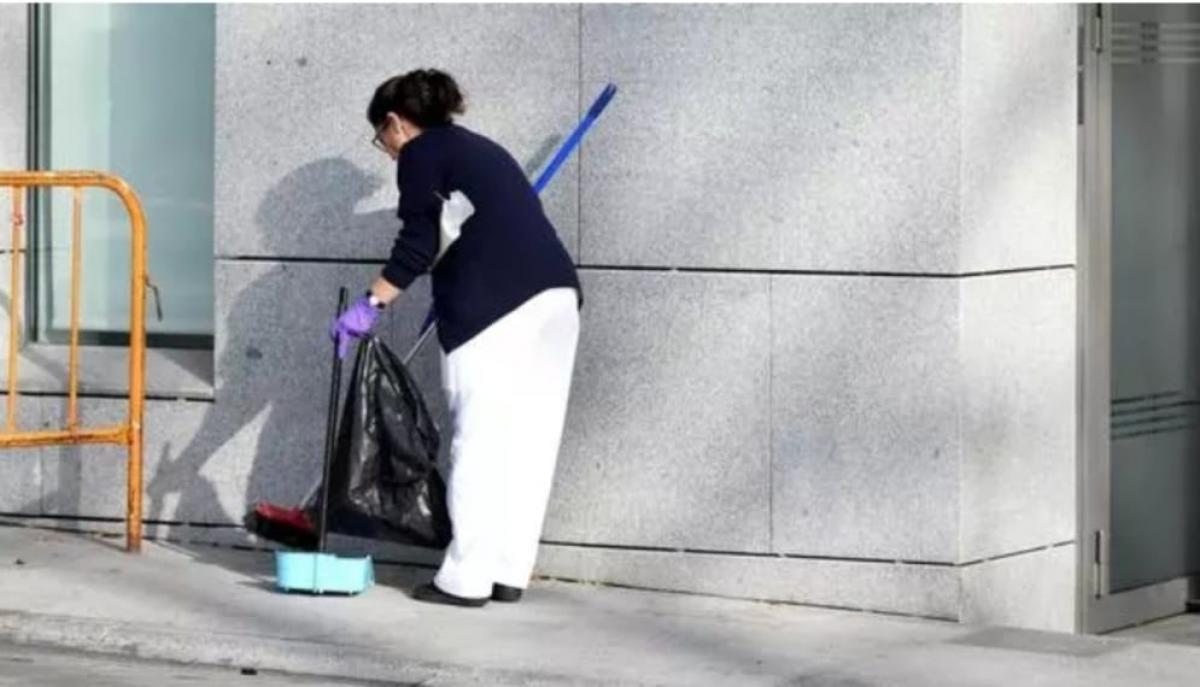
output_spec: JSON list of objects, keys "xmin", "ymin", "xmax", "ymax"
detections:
[{"xmin": 961, "ymin": 544, "xmax": 1076, "ymax": 632}]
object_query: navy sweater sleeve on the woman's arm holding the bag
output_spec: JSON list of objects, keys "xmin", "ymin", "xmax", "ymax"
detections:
[{"xmin": 383, "ymin": 141, "xmax": 443, "ymax": 289}]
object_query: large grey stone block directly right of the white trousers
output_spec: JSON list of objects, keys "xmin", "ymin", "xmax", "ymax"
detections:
[{"xmin": 545, "ymin": 270, "xmax": 770, "ymax": 551}]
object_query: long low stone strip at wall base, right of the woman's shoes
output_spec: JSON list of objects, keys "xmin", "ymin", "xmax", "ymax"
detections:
[{"xmin": 538, "ymin": 544, "xmax": 959, "ymax": 620}]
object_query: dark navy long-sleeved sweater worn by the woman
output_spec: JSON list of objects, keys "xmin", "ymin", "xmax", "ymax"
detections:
[{"xmin": 383, "ymin": 125, "xmax": 583, "ymax": 353}]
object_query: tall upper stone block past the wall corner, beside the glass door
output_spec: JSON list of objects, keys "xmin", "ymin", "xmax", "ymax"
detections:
[{"xmin": 960, "ymin": 4, "xmax": 1079, "ymax": 271}]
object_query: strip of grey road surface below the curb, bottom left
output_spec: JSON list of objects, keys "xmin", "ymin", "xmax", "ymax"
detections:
[{"xmin": 0, "ymin": 643, "xmax": 378, "ymax": 687}]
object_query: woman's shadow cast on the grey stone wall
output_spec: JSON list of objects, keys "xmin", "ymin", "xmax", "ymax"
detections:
[{"xmin": 146, "ymin": 157, "xmax": 408, "ymax": 533}]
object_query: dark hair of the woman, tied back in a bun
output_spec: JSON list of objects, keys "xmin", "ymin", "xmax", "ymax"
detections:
[{"xmin": 367, "ymin": 70, "xmax": 467, "ymax": 129}]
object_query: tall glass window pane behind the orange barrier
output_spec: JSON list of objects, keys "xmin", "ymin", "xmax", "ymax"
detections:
[{"xmin": 34, "ymin": 5, "xmax": 215, "ymax": 345}]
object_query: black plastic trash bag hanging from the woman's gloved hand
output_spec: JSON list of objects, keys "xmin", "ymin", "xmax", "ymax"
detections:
[{"xmin": 310, "ymin": 336, "xmax": 450, "ymax": 549}]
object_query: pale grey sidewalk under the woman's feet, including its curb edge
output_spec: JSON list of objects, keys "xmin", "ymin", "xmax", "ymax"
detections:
[{"xmin": 0, "ymin": 527, "xmax": 1200, "ymax": 687}]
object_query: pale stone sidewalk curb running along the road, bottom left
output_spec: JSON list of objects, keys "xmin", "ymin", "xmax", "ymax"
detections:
[{"xmin": 0, "ymin": 609, "xmax": 600, "ymax": 686}]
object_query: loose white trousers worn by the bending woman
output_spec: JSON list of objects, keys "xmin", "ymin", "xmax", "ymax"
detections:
[{"xmin": 434, "ymin": 288, "xmax": 580, "ymax": 598}]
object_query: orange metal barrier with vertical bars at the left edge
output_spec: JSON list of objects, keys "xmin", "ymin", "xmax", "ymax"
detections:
[{"xmin": 0, "ymin": 172, "xmax": 148, "ymax": 551}]
